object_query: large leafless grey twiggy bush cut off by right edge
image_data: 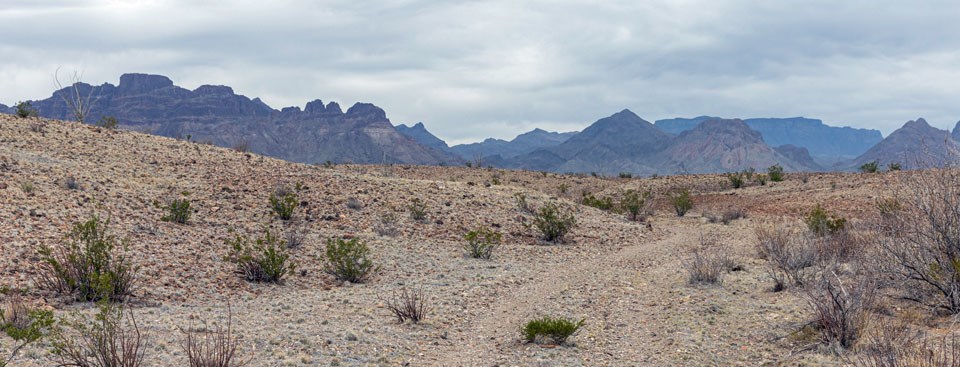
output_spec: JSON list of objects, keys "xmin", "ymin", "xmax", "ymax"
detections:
[{"xmin": 878, "ymin": 167, "xmax": 960, "ymax": 314}]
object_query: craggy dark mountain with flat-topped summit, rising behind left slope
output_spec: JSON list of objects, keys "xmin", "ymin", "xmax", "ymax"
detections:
[{"xmin": 15, "ymin": 74, "xmax": 459, "ymax": 164}]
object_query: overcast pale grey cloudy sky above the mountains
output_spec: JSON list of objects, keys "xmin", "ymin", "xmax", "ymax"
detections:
[{"xmin": 0, "ymin": 0, "xmax": 960, "ymax": 144}]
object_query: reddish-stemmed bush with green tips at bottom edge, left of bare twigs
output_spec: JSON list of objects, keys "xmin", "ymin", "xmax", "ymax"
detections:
[{"xmin": 50, "ymin": 303, "xmax": 150, "ymax": 367}]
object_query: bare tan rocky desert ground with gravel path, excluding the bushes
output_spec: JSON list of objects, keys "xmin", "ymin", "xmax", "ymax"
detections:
[{"xmin": 0, "ymin": 115, "xmax": 951, "ymax": 366}]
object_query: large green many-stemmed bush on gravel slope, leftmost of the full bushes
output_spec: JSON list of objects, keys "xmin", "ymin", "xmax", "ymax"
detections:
[{"xmin": 38, "ymin": 216, "xmax": 136, "ymax": 302}]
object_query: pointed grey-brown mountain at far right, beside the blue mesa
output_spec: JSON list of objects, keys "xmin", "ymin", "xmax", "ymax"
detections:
[{"xmin": 848, "ymin": 118, "xmax": 960, "ymax": 170}]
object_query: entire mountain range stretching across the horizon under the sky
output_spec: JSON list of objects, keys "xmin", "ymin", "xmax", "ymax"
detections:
[{"xmin": 7, "ymin": 74, "xmax": 960, "ymax": 175}]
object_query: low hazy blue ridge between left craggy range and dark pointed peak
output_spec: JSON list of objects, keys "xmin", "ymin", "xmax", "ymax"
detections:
[{"xmin": 450, "ymin": 129, "xmax": 576, "ymax": 160}]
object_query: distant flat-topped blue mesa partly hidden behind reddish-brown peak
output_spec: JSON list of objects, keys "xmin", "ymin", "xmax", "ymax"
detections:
[{"xmin": 656, "ymin": 116, "xmax": 883, "ymax": 165}]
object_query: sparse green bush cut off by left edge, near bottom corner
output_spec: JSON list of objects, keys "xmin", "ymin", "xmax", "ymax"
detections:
[{"xmin": 0, "ymin": 291, "xmax": 54, "ymax": 367}]
